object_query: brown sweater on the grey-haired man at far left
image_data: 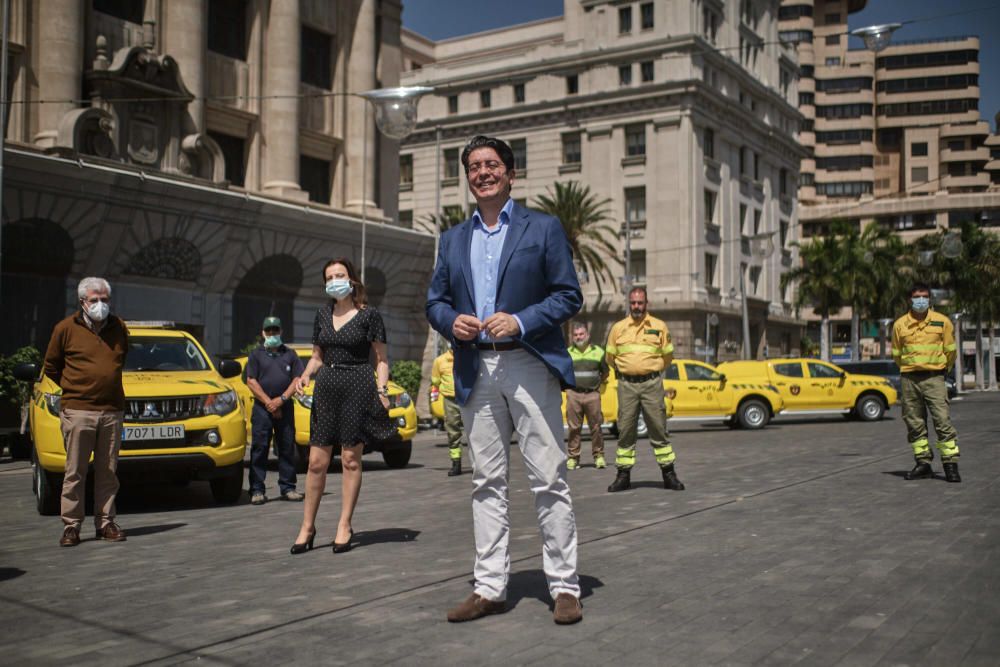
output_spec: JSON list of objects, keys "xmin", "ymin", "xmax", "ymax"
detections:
[{"xmin": 45, "ymin": 312, "xmax": 128, "ymax": 411}]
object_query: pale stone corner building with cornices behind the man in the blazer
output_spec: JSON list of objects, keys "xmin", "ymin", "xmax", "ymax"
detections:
[{"xmin": 399, "ymin": 0, "xmax": 805, "ymax": 361}]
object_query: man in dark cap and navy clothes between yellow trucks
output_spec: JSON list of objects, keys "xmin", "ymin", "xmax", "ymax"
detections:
[{"xmin": 247, "ymin": 317, "xmax": 304, "ymax": 505}]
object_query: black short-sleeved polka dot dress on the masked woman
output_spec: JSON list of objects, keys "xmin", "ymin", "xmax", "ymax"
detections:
[{"xmin": 309, "ymin": 302, "xmax": 399, "ymax": 447}]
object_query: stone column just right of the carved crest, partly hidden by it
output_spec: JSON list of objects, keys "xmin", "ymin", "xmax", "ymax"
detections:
[{"xmin": 162, "ymin": 0, "xmax": 208, "ymax": 135}]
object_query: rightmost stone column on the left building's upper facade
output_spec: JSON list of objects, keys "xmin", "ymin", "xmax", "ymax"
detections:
[{"xmin": 345, "ymin": 0, "xmax": 377, "ymax": 216}]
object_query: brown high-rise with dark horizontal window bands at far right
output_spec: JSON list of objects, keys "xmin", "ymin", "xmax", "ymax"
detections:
[{"xmin": 779, "ymin": 0, "xmax": 1000, "ymax": 360}]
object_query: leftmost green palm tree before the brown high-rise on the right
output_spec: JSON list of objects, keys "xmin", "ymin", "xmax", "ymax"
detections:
[{"xmin": 781, "ymin": 235, "xmax": 844, "ymax": 361}]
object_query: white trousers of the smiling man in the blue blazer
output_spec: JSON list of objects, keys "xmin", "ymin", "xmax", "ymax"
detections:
[{"xmin": 462, "ymin": 350, "xmax": 580, "ymax": 600}]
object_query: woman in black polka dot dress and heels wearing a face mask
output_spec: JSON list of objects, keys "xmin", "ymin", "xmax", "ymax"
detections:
[{"xmin": 292, "ymin": 258, "xmax": 399, "ymax": 554}]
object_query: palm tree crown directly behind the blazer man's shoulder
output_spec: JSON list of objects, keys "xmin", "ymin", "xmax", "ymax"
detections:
[{"xmin": 534, "ymin": 181, "xmax": 623, "ymax": 290}]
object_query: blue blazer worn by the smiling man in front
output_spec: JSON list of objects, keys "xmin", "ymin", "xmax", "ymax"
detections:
[{"xmin": 427, "ymin": 202, "xmax": 583, "ymax": 405}]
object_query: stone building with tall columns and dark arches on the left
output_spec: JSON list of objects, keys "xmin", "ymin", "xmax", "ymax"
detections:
[{"xmin": 2, "ymin": 0, "xmax": 434, "ymax": 359}]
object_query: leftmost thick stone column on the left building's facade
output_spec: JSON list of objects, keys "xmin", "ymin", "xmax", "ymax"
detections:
[{"xmin": 34, "ymin": 0, "xmax": 83, "ymax": 148}]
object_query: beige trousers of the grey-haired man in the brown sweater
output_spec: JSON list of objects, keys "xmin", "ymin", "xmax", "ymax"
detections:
[{"xmin": 59, "ymin": 408, "xmax": 123, "ymax": 530}]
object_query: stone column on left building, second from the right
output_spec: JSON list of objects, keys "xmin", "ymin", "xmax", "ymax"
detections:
[{"xmin": 262, "ymin": 0, "xmax": 309, "ymax": 200}]
